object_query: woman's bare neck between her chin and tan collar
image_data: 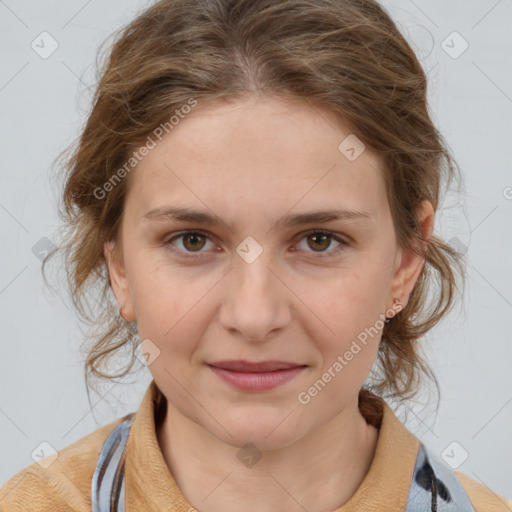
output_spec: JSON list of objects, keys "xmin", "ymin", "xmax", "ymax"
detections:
[{"xmin": 157, "ymin": 394, "xmax": 379, "ymax": 512}]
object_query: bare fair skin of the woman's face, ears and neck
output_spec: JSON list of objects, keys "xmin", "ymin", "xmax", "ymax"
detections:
[{"xmin": 105, "ymin": 98, "xmax": 434, "ymax": 512}]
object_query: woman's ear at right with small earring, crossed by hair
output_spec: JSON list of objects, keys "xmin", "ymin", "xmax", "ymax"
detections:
[{"xmin": 389, "ymin": 200, "xmax": 435, "ymax": 309}]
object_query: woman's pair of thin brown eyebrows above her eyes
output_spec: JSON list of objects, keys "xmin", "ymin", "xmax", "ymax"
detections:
[{"xmin": 143, "ymin": 206, "xmax": 372, "ymax": 227}]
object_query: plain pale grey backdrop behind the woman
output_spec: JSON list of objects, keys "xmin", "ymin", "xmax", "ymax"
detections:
[{"xmin": 0, "ymin": 0, "xmax": 512, "ymax": 498}]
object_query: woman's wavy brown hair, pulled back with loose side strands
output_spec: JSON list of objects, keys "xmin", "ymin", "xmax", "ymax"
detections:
[{"xmin": 43, "ymin": 0, "xmax": 465, "ymax": 414}]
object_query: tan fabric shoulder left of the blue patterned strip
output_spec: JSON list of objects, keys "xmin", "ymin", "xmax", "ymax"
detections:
[{"xmin": 0, "ymin": 416, "xmax": 126, "ymax": 512}]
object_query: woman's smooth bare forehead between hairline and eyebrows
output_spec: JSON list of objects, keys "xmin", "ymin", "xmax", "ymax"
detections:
[{"xmin": 127, "ymin": 98, "xmax": 386, "ymax": 224}]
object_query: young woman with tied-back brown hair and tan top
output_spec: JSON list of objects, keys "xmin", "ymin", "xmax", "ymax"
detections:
[{"xmin": 1, "ymin": 0, "xmax": 512, "ymax": 512}]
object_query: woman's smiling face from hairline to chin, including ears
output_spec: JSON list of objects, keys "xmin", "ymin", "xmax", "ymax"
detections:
[{"xmin": 105, "ymin": 95, "xmax": 433, "ymax": 449}]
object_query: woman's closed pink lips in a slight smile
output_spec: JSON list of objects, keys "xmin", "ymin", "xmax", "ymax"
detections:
[{"xmin": 208, "ymin": 361, "xmax": 306, "ymax": 391}]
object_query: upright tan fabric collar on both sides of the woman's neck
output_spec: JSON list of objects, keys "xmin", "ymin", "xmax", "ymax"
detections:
[{"xmin": 125, "ymin": 380, "xmax": 420, "ymax": 512}]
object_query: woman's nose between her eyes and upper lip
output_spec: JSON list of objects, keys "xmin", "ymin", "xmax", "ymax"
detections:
[{"xmin": 220, "ymin": 251, "xmax": 293, "ymax": 341}]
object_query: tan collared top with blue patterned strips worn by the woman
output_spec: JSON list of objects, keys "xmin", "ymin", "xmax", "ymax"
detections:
[{"xmin": 0, "ymin": 380, "xmax": 512, "ymax": 512}]
